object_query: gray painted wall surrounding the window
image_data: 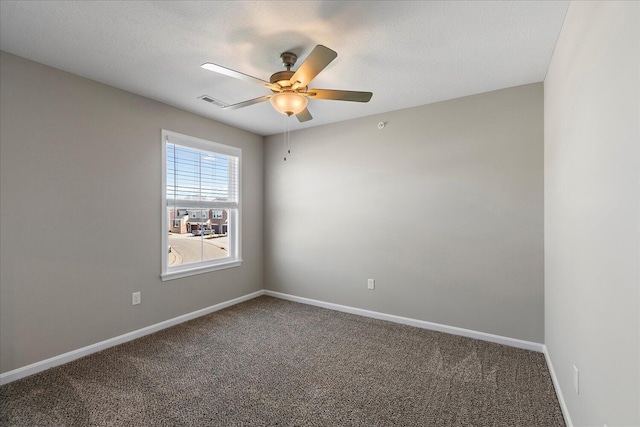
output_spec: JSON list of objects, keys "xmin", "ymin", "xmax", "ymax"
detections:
[{"xmin": 0, "ymin": 53, "xmax": 263, "ymax": 372}]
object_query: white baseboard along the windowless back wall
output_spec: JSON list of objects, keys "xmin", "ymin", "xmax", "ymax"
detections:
[{"xmin": 264, "ymin": 290, "xmax": 544, "ymax": 353}]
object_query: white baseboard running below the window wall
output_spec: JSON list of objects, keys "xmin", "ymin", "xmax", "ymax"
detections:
[{"xmin": 0, "ymin": 290, "xmax": 264, "ymax": 385}]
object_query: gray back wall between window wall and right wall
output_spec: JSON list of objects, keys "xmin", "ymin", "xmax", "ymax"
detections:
[{"xmin": 265, "ymin": 83, "xmax": 544, "ymax": 343}]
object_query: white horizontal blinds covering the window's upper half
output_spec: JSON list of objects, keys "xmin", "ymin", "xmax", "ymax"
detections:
[{"xmin": 166, "ymin": 139, "xmax": 239, "ymax": 209}]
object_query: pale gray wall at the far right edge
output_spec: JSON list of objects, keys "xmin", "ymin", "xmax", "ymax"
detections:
[{"xmin": 544, "ymin": 1, "xmax": 640, "ymax": 426}]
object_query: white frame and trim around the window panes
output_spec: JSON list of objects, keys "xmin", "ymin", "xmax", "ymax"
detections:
[{"xmin": 160, "ymin": 129, "xmax": 242, "ymax": 281}]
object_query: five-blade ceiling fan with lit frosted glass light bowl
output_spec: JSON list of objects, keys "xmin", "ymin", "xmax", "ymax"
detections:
[{"xmin": 202, "ymin": 45, "xmax": 373, "ymax": 122}]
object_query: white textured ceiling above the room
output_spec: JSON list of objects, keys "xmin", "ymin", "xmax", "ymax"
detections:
[{"xmin": 0, "ymin": 0, "xmax": 568, "ymax": 135}]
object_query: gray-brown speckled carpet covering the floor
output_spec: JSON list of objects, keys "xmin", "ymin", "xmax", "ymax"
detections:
[{"xmin": 0, "ymin": 297, "xmax": 565, "ymax": 427}]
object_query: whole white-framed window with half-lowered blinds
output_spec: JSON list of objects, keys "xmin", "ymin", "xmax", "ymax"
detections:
[{"xmin": 162, "ymin": 130, "xmax": 242, "ymax": 280}]
